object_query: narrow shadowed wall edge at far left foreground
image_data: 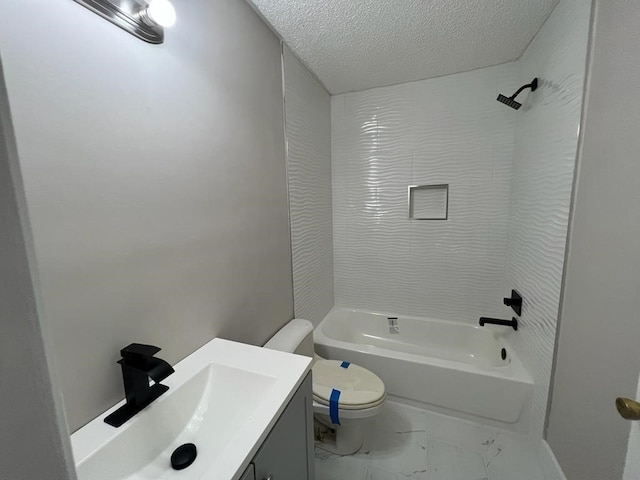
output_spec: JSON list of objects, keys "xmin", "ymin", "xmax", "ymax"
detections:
[{"xmin": 0, "ymin": 55, "xmax": 75, "ymax": 480}]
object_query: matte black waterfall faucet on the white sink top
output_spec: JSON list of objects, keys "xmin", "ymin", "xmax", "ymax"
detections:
[{"xmin": 104, "ymin": 343, "xmax": 174, "ymax": 427}]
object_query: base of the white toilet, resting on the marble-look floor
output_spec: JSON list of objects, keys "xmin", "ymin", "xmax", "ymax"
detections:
[{"xmin": 313, "ymin": 413, "xmax": 363, "ymax": 455}]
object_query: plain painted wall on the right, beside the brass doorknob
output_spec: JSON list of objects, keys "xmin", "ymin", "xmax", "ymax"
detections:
[{"xmin": 547, "ymin": 0, "xmax": 640, "ymax": 480}]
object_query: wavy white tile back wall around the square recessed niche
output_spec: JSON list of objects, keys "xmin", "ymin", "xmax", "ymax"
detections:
[{"xmin": 332, "ymin": 64, "xmax": 518, "ymax": 323}]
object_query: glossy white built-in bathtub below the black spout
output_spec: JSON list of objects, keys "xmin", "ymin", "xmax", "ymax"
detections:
[{"xmin": 314, "ymin": 308, "xmax": 533, "ymax": 424}]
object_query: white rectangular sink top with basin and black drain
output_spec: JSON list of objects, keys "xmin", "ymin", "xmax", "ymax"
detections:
[{"xmin": 71, "ymin": 339, "xmax": 311, "ymax": 480}]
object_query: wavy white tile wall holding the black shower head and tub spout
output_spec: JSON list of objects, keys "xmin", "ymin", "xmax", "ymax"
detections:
[{"xmin": 504, "ymin": 0, "xmax": 591, "ymax": 437}]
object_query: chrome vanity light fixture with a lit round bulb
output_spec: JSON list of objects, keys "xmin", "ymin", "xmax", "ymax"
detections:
[{"xmin": 75, "ymin": 0, "xmax": 176, "ymax": 44}]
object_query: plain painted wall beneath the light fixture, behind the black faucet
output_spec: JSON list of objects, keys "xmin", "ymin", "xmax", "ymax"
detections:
[{"xmin": 0, "ymin": 0, "xmax": 293, "ymax": 430}]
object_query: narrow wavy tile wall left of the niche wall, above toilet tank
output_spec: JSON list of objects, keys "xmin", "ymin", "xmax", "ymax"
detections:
[{"xmin": 282, "ymin": 46, "xmax": 333, "ymax": 325}]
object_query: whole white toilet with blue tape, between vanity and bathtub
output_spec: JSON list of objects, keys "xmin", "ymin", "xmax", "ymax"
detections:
[{"xmin": 264, "ymin": 319, "xmax": 386, "ymax": 455}]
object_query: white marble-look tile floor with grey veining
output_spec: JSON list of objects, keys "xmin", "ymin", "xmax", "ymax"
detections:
[{"xmin": 315, "ymin": 401, "xmax": 545, "ymax": 480}]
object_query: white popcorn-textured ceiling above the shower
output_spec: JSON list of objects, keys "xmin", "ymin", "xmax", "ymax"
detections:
[{"xmin": 249, "ymin": 0, "xmax": 558, "ymax": 94}]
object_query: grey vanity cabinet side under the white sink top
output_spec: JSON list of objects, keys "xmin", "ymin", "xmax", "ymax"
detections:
[{"xmin": 240, "ymin": 373, "xmax": 315, "ymax": 480}]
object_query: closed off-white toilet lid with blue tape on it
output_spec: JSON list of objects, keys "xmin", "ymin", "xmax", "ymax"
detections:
[{"xmin": 313, "ymin": 360, "xmax": 385, "ymax": 408}]
